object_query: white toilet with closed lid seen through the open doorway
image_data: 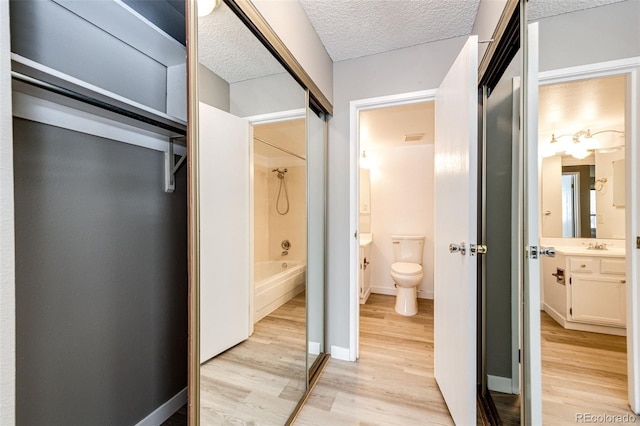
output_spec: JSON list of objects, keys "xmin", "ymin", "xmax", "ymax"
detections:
[{"xmin": 391, "ymin": 235, "xmax": 424, "ymax": 316}]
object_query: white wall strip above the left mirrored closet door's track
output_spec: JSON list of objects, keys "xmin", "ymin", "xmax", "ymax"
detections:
[{"xmin": 251, "ymin": 0, "xmax": 333, "ymax": 103}]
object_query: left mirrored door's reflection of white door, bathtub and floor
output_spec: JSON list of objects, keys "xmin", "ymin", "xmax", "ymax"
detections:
[{"xmin": 198, "ymin": 3, "xmax": 307, "ymax": 425}]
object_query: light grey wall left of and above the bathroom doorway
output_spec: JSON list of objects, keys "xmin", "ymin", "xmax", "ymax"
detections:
[{"xmin": 327, "ymin": 37, "xmax": 467, "ymax": 348}]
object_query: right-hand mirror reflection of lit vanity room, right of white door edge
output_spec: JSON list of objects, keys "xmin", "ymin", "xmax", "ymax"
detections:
[{"xmin": 530, "ymin": 0, "xmax": 640, "ymax": 424}]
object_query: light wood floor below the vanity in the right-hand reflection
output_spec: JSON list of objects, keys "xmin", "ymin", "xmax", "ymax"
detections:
[{"xmin": 540, "ymin": 312, "xmax": 640, "ymax": 425}]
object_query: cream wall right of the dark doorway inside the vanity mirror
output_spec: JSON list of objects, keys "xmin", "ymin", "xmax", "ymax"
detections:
[{"xmin": 596, "ymin": 151, "xmax": 626, "ymax": 239}]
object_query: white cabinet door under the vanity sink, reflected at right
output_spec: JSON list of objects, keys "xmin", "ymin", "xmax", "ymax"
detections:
[{"xmin": 570, "ymin": 275, "xmax": 626, "ymax": 327}]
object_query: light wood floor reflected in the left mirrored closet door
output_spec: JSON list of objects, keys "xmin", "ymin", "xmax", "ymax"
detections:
[{"xmin": 200, "ymin": 293, "xmax": 306, "ymax": 425}]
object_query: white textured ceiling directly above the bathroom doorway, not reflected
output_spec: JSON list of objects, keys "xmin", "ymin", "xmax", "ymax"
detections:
[{"xmin": 300, "ymin": 0, "xmax": 480, "ymax": 62}]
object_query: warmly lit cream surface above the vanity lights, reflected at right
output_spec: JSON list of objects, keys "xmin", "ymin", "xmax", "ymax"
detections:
[{"xmin": 538, "ymin": 76, "xmax": 625, "ymax": 142}]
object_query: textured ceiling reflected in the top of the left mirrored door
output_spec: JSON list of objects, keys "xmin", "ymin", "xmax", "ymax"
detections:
[{"xmin": 198, "ymin": 3, "xmax": 284, "ymax": 83}]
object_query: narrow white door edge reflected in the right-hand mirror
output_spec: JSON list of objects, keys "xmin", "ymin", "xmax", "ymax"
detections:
[{"xmin": 521, "ymin": 22, "xmax": 542, "ymax": 425}]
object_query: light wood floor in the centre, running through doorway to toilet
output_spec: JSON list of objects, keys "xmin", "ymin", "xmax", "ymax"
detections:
[{"xmin": 294, "ymin": 294, "xmax": 453, "ymax": 426}]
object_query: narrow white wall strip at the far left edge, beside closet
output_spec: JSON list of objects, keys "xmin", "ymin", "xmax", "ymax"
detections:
[{"xmin": 0, "ymin": 0, "xmax": 16, "ymax": 425}]
